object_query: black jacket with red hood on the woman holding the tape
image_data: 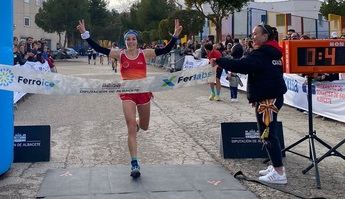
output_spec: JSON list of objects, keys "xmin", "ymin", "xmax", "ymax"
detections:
[{"xmin": 216, "ymin": 41, "xmax": 287, "ymax": 103}]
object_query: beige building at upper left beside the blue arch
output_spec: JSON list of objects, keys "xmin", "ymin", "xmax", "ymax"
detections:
[{"xmin": 13, "ymin": 0, "xmax": 64, "ymax": 50}]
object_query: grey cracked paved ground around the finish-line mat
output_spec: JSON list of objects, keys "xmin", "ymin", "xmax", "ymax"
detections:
[{"xmin": 0, "ymin": 58, "xmax": 345, "ymax": 199}]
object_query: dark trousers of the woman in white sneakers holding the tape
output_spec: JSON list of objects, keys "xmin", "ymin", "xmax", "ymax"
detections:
[{"xmin": 255, "ymin": 96, "xmax": 284, "ymax": 167}]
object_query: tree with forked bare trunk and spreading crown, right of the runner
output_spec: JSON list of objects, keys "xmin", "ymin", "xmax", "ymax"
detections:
[{"xmin": 185, "ymin": 0, "xmax": 249, "ymax": 42}]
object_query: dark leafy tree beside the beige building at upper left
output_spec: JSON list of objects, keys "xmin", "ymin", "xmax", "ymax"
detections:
[{"xmin": 35, "ymin": 0, "xmax": 88, "ymax": 47}]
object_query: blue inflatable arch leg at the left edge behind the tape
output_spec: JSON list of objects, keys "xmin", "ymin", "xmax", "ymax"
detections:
[{"xmin": 0, "ymin": 0, "xmax": 13, "ymax": 175}]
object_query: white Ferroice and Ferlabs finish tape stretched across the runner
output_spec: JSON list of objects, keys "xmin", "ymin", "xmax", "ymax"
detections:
[{"xmin": 0, "ymin": 65, "xmax": 215, "ymax": 95}]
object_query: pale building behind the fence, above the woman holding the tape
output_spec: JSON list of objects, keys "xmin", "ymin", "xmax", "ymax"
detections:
[{"xmin": 203, "ymin": 0, "xmax": 330, "ymax": 40}]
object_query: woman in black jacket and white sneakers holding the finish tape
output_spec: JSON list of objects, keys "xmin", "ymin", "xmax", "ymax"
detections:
[{"xmin": 211, "ymin": 25, "xmax": 287, "ymax": 184}]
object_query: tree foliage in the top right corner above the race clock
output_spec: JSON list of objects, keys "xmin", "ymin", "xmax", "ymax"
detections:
[{"xmin": 320, "ymin": 0, "xmax": 345, "ymax": 19}]
